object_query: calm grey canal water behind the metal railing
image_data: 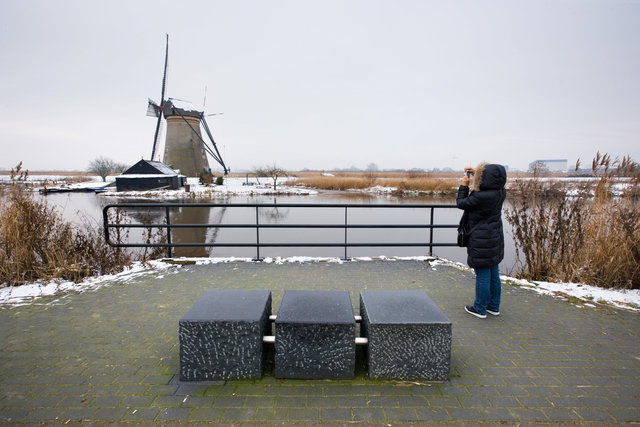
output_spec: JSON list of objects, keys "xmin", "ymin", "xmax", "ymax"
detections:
[{"xmin": 43, "ymin": 192, "xmax": 515, "ymax": 274}]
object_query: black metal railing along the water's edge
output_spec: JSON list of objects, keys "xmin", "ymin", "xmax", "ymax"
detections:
[{"xmin": 102, "ymin": 203, "xmax": 458, "ymax": 260}]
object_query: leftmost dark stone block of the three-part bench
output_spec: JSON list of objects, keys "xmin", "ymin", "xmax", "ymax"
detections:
[{"xmin": 178, "ymin": 289, "xmax": 271, "ymax": 381}]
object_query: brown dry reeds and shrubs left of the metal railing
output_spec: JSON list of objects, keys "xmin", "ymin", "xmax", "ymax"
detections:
[{"xmin": 0, "ymin": 165, "xmax": 132, "ymax": 286}]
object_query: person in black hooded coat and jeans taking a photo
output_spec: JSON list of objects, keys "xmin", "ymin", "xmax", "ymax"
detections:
[{"xmin": 456, "ymin": 163, "xmax": 507, "ymax": 319}]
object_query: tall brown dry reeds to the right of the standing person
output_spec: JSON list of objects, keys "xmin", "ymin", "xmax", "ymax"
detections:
[{"xmin": 506, "ymin": 153, "xmax": 640, "ymax": 289}]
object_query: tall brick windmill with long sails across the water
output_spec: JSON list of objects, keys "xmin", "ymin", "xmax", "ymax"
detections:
[{"xmin": 147, "ymin": 34, "xmax": 229, "ymax": 176}]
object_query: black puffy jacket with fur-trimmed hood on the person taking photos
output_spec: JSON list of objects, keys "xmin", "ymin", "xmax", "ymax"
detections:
[{"xmin": 456, "ymin": 163, "xmax": 507, "ymax": 268}]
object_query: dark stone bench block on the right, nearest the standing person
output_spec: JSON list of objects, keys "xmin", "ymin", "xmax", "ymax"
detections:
[{"xmin": 360, "ymin": 291, "xmax": 451, "ymax": 381}]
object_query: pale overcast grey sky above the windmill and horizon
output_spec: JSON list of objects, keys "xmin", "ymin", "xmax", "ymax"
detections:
[{"xmin": 0, "ymin": 0, "xmax": 640, "ymax": 171}]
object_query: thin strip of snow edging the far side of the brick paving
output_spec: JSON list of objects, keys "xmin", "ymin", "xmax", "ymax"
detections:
[{"xmin": 0, "ymin": 256, "xmax": 640, "ymax": 312}]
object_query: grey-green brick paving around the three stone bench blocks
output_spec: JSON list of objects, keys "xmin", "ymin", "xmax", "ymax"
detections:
[{"xmin": 0, "ymin": 261, "xmax": 640, "ymax": 424}]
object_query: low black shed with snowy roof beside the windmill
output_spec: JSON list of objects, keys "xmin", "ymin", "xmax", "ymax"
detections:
[{"xmin": 116, "ymin": 160, "xmax": 187, "ymax": 191}]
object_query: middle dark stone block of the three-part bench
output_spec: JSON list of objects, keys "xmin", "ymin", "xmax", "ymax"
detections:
[{"xmin": 275, "ymin": 291, "xmax": 356, "ymax": 379}]
